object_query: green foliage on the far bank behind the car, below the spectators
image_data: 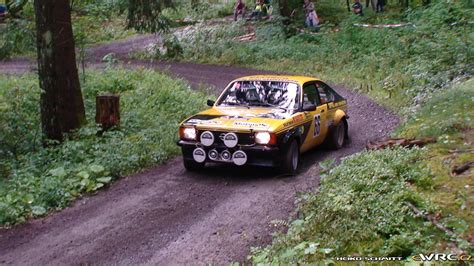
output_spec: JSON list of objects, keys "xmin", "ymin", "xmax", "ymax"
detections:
[{"xmin": 160, "ymin": 1, "xmax": 474, "ymax": 110}]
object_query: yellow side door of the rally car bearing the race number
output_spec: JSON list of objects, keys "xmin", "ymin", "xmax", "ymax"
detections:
[{"xmin": 301, "ymin": 82, "xmax": 328, "ymax": 152}]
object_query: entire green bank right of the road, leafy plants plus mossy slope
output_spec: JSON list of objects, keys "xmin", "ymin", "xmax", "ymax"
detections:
[{"xmin": 251, "ymin": 80, "xmax": 474, "ymax": 264}]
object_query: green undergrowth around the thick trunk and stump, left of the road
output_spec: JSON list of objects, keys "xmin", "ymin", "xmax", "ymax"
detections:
[{"xmin": 0, "ymin": 69, "xmax": 205, "ymax": 226}]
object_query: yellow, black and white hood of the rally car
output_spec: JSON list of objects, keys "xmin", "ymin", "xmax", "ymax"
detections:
[{"xmin": 183, "ymin": 107, "xmax": 292, "ymax": 132}]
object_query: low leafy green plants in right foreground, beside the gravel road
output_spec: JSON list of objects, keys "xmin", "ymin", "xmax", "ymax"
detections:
[{"xmin": 251, "ymin": 148, "xmax": 446, "ymax": 265}]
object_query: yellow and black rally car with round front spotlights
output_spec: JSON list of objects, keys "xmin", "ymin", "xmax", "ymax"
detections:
[{"xmin": 178, "ymin": 75, "xmax": 349, "ymax": 173}]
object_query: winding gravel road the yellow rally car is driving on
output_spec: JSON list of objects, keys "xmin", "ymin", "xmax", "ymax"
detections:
[{"xmin": 0, "ymin": 37, "xmax": 398, "ymax": 265}]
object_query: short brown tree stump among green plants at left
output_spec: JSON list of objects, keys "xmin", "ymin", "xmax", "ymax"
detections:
[{"xmin": 95, "ymin": 94, "xmax": 120, "ymax": 130}]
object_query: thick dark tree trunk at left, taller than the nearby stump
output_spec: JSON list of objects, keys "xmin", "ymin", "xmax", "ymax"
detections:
[{"xmin": 34, "ymin": 0, "xmax": 86, "ymax": 141}]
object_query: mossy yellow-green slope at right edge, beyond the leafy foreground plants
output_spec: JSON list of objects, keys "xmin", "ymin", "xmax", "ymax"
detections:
[{"xmin": 396, "ymin": 79, "xmax": 474, "ymax": 243}]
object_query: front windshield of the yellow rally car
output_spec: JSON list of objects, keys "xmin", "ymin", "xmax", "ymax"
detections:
[{"xmin": 217, "ymin": 81, "xmax": 299, "ymax": 111}]
